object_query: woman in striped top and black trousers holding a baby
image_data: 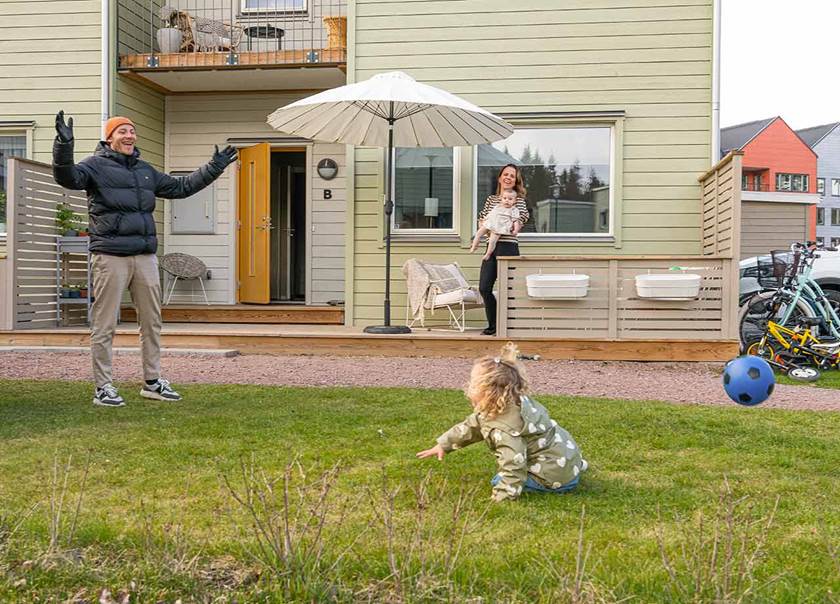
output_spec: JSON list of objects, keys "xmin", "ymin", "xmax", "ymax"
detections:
[{"xmin": 473, "ymin": 164, "xmax": 528, "ymax": 336}]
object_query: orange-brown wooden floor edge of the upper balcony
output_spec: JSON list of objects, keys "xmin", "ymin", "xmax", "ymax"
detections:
[{"xmin": 119, "ymin": 48, "xmax": 347, "ymax": 71}]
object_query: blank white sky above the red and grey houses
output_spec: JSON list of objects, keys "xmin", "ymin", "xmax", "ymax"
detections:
[{"xmin": 720, "ymin": 0, "xmax": 840, "ymax": 129}]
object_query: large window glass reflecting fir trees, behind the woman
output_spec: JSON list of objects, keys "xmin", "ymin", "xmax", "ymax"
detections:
[{"xmin": 476, "ymin": 126, "xmax": 612, "ymax": 235}]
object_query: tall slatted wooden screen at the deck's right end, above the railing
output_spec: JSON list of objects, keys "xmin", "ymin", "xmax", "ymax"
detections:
[{"xmin": 700, "ymin": 152, "xmax": 743, "ymax": 258}]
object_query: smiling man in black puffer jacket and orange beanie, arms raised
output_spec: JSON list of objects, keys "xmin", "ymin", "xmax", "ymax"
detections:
[{"xmin": 53, "ymin": 111, "xmax": 236, "ymax": 407}]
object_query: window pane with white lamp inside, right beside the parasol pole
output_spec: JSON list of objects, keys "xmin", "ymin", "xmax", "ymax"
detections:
[{"xmin": 393, "ymin": 148, "xmax": 456, "ymax": 232}]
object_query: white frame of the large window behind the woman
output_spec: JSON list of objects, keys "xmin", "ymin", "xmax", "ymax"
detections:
[{"xmin": 472, "ymin": 119, "xmax": 617, "ymax": 242}]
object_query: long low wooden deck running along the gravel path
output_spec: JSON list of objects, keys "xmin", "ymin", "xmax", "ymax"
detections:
[{"xmin": 0, "ymin": 323, "xmax": 738, "ymax": 361}]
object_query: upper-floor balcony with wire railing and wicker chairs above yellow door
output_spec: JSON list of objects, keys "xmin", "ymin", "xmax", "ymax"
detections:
[{"xmin": 117, "ymin": 0, "xmax": 347, "ymax": 92}]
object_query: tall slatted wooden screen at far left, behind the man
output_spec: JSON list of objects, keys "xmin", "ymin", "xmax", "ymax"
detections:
[{"xmin": 3, "ymin": 158, "xmax": 87, "ymax": 329}]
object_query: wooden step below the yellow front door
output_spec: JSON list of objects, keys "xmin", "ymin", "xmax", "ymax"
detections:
[{"xmin": 120, "ymin": 304, "xmax": 344, "ymax": 325}]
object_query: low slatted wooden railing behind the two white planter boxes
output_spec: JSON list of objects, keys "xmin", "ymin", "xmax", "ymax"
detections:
[{"xmin": 499, "ymin": 256, "xmax": 737, "ymax": 340}]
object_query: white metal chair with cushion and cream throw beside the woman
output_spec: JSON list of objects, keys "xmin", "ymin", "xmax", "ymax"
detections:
[{"xmin": 403, "ymin": 259, "xmax": 484, "ymax": 333}]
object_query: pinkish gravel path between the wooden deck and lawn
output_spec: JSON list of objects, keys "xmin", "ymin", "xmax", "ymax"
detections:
[{"xmin": 0, "ymin": 352, "xmax": 840, "ymax": 411}]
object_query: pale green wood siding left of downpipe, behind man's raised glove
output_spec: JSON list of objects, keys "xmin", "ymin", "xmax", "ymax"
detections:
[{"xmin": 0, "ymin": 0, "xmax": 100, "ymax": 163}]
